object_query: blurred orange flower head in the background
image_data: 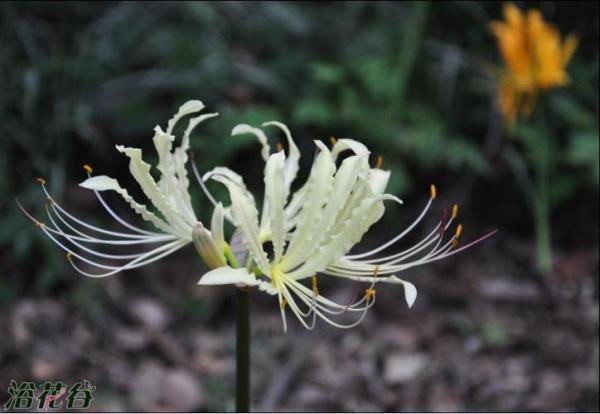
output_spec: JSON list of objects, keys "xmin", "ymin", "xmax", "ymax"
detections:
[{"xmin": 491, "ymin": 3, "xmax": 577, "ymax": 122}]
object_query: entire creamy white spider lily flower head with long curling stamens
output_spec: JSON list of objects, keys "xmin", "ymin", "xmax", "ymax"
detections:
[{"xmin": 19, "ymin": 101, "xmax": 493, "ymax": 329}]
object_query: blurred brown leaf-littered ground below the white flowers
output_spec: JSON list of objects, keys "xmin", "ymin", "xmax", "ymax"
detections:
[{"xmin": 0, "ymin": 236, "xmax": 598, "ymax": 411}]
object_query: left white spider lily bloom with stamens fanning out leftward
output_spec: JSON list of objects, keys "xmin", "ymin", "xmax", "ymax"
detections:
[{"xmin": 19, "ymin": 100, "xmax": 225, "ymax": 277}]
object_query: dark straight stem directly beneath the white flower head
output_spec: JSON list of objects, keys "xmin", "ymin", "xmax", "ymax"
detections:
[{"xmin": 235, "ymin": 288, "xmax": 250, "ymax": 413}]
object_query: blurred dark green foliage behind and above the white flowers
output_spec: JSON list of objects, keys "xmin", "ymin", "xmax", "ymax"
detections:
[{"xmin": 0, "ymin": 2, "xmax": 598, "ymax": 301}]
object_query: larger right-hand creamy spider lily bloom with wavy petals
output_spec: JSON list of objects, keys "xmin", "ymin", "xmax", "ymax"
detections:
[{"xmin": 197, "ymin": 122, "xmax": 496, "ymax": 329}]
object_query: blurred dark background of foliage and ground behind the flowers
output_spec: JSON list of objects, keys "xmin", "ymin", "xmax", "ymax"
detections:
[{"xmin": 0, "ymin": 2, "xmax": 599, "ymax": 411}]
